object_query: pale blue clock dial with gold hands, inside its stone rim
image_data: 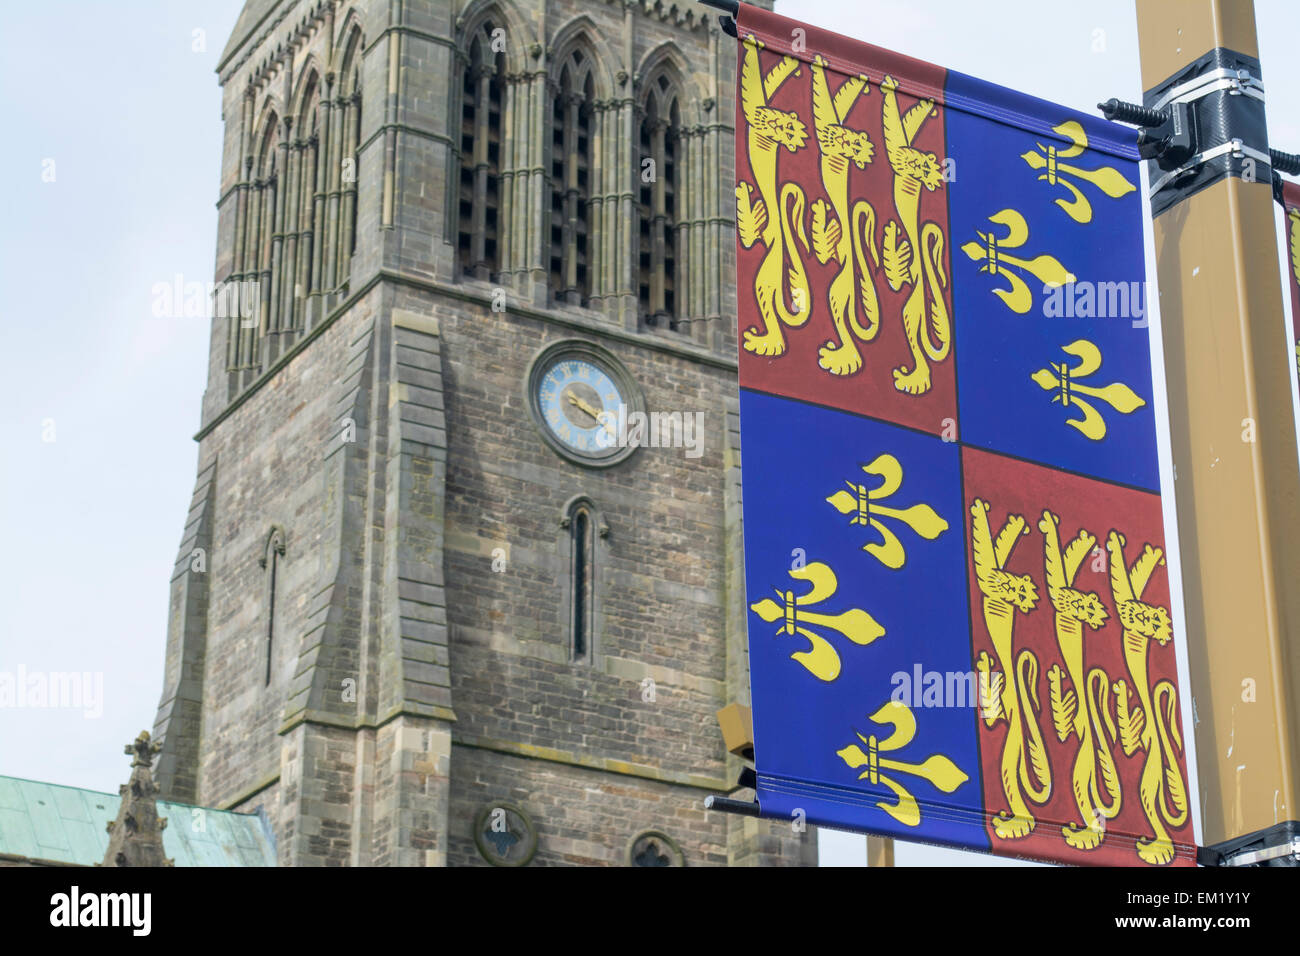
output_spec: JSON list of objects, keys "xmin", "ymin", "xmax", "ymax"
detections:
[{"xmin": 537, "ymin": 358, "xmax": 625, "ymax": 458}]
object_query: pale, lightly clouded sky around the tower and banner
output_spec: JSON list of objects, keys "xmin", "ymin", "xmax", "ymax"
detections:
[{"xmin": 0, "ymin": 0, "xmax": 1300, "ymax": 865}]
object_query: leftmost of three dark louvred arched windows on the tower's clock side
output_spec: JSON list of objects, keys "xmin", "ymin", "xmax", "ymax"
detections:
[{"xmin": 456, "ymin": 20, "xmax": 506, "ymax": 278}]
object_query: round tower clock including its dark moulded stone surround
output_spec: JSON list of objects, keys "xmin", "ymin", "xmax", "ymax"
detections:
[{"xmin": 525, "ymin": 339, "xmax": 644, "ymax": 468}]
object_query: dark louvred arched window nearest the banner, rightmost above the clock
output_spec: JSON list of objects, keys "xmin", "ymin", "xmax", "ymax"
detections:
[{"xmin": 637, "ymin": 73, "xmax": 681, "ymax": 329}]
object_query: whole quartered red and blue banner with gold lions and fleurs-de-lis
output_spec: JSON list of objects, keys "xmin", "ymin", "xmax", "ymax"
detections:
[{"xmin": 736, "ymin": 4, "xmax": 1195, "ymax": 866}]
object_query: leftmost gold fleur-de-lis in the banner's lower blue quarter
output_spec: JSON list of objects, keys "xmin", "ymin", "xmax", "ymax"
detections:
[{"xmin": 749, "ymin": 561, "xmax": 885, "ymax": 682}]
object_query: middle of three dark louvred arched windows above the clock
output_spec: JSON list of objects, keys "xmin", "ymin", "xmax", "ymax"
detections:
[{"xmin": 550, "ymin": 48, "xmax": 594, "ymax": 306}]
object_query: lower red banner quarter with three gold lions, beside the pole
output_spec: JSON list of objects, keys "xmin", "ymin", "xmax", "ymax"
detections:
[{"xmin": 962, "ymin": 449, "xmax": 1195, "ymax": 866}]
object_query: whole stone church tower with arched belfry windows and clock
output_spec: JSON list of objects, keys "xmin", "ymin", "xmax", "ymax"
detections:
[{"xmin": 155, "ymin": 0, "xmax": 816, "ymax": 866}]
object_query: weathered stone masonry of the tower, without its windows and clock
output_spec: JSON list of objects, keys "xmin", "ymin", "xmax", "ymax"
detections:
[{"xmin": 160, "ymin": 0, "xmax": 815, "ymax": 865}]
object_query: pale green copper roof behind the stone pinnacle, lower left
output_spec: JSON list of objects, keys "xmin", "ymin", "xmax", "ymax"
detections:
[{"xmin": 0, "ymin": 777, "xmax": 276, "ymax": 866}]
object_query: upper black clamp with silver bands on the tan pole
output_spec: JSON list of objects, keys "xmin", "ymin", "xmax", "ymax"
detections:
[{"xmin": 1099, "ymin": 47, "xmax": 1268, "ymax": 216}]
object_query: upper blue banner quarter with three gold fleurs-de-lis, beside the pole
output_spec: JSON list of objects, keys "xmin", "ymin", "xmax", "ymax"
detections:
[{"xmin": 946, "ymin": 73, "xmax": 1160, "ymax": 490}]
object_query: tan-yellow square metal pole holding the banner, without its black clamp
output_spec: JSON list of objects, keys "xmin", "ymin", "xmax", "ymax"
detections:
[{"xmin": 1138, "ymin": 0, "xmax": 1300, "ymax": 862}]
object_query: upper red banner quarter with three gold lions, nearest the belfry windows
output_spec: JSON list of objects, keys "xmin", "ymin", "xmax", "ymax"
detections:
[{"xmin": 736, "ymin": 10, "xmax": 957, "ymax": 434}]
